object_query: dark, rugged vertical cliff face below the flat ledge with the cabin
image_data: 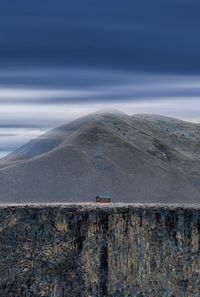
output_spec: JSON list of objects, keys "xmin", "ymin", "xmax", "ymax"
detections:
[{"xmin": 0, "ymin": 204, "xmax": 200, "ymax": 297}]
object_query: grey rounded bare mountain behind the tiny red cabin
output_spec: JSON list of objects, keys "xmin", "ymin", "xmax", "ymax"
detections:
[{"xmin": 0, "ymin": 112, "xmax": 200, "ymax": 203}]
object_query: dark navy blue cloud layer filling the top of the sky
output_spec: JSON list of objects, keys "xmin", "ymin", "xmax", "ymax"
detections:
[{"xmin": 0, "ymin": 0, "xmax": 200, "ymax": 73}]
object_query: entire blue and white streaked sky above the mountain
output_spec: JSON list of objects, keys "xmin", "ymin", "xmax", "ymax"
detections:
[{"xmin": 0, "ymin": 0, "xmax": 200, "ymax": 157}]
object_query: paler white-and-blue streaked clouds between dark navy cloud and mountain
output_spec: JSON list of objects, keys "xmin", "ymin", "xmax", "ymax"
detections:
[{"xmin": 0, "ymin": 69, "xmax": 200, "ymax": 156}]
